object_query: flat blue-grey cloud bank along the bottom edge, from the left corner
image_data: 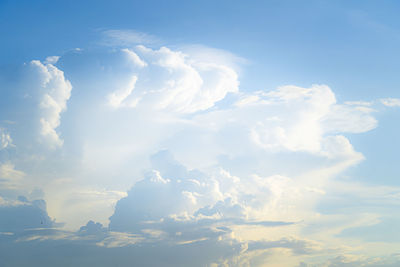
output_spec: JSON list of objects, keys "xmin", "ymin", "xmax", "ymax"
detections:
[{"xmin": 0, "ymin": 217, "xmax": 314, "ymax": 267}]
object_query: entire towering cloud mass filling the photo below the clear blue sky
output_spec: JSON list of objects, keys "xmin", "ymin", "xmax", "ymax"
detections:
[{"xmin": 0, "ymin": 43, "xmax": 400, "ymax": 266}]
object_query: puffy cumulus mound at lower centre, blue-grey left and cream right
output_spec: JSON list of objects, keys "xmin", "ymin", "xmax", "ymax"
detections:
[{"xmin": 109, "ymin": 151, "xmax": 321, "ymax": 251}]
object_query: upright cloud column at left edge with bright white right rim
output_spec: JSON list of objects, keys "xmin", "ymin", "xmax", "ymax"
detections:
[{"xmin": 0, "ymin": 57, "xmax": 72, "ymax": 151}]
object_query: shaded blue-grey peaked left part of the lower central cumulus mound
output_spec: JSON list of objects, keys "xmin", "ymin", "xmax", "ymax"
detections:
[{"xmin": 110, "ymin": 151, "xmax": 223, "ymax": 232}]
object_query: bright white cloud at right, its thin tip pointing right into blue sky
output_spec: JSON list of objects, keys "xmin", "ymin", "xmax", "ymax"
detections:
[{"xmin": 189, "ymin": 85, "xmax": 377, "ymax": 159}]
